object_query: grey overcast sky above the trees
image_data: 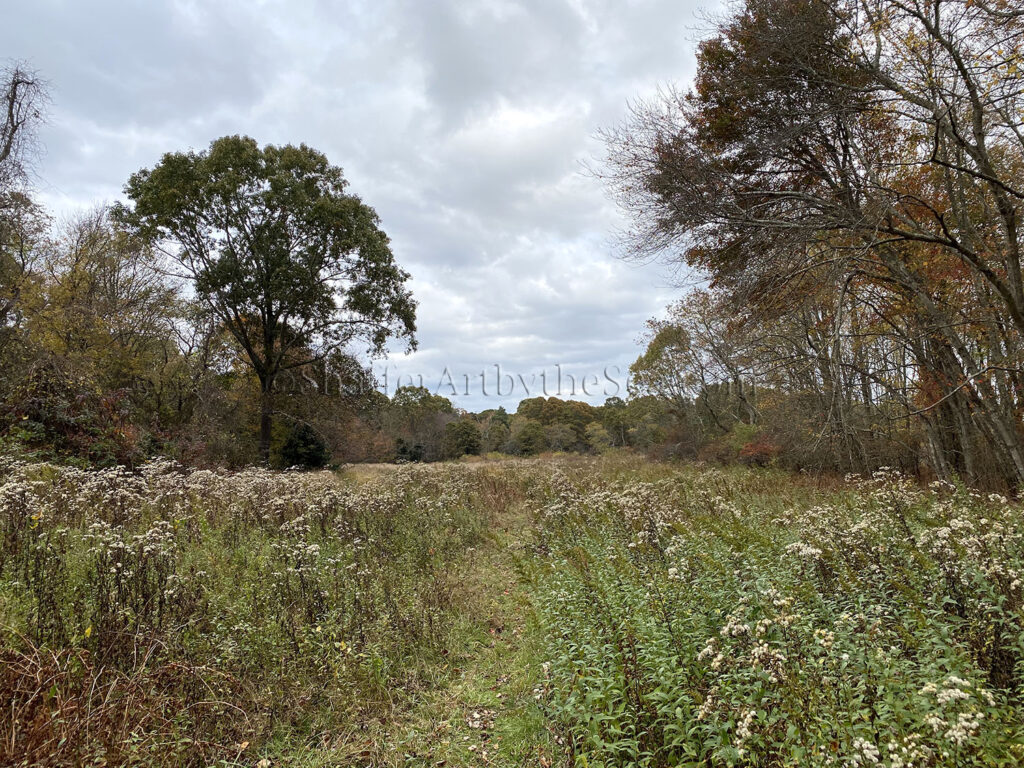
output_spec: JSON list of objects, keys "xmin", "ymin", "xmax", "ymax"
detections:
[{"xmin": 0, "ymin": 0, "xmax": 715, "ymax": 410}]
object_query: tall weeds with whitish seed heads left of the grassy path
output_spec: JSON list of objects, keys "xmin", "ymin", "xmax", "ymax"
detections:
[{"xmin": 0, "ymin": 463, "xmax": 489, "ymax": 765}]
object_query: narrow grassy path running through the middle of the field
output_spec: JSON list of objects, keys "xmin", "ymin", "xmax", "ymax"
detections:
[{"xmin": 327, "ymin": 472, "xmax": 557, "ymax": 767}]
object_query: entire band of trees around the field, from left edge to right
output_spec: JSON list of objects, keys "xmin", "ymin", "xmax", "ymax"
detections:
[{"xmin": 8, "ymin": 0, "xmax": 1024, "ymax": 488}]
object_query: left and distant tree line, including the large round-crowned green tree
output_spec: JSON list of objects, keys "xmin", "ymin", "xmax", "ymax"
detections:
[{"xmin": 0, "ymin": 65, "xmax": 667, "ymax": 467}]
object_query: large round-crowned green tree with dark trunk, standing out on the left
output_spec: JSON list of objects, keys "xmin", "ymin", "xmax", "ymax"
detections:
[{"xmin": 118, "ymin": 136, "xmax": 416, "ymax": 462}]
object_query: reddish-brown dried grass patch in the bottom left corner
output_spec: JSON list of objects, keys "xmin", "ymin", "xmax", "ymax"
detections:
[{"xmin": 0, "ymin": 648, "xmax": 260, "ymax": 766}]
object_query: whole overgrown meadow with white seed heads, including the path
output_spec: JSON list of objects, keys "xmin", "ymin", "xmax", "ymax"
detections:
[{"xmin": 0, "ymin": 457, "xmax": 1024, "ymax": 768}]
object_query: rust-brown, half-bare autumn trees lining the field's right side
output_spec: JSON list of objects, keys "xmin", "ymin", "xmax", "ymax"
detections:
[{"xmin": 607, "ymin": 0, "xmax": 1024, "ymax": 487}]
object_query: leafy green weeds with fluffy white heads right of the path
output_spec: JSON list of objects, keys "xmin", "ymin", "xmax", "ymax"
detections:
[{"xmin": 536, "ymin": 470, "xmax": 1024, "ymax": 768}]
